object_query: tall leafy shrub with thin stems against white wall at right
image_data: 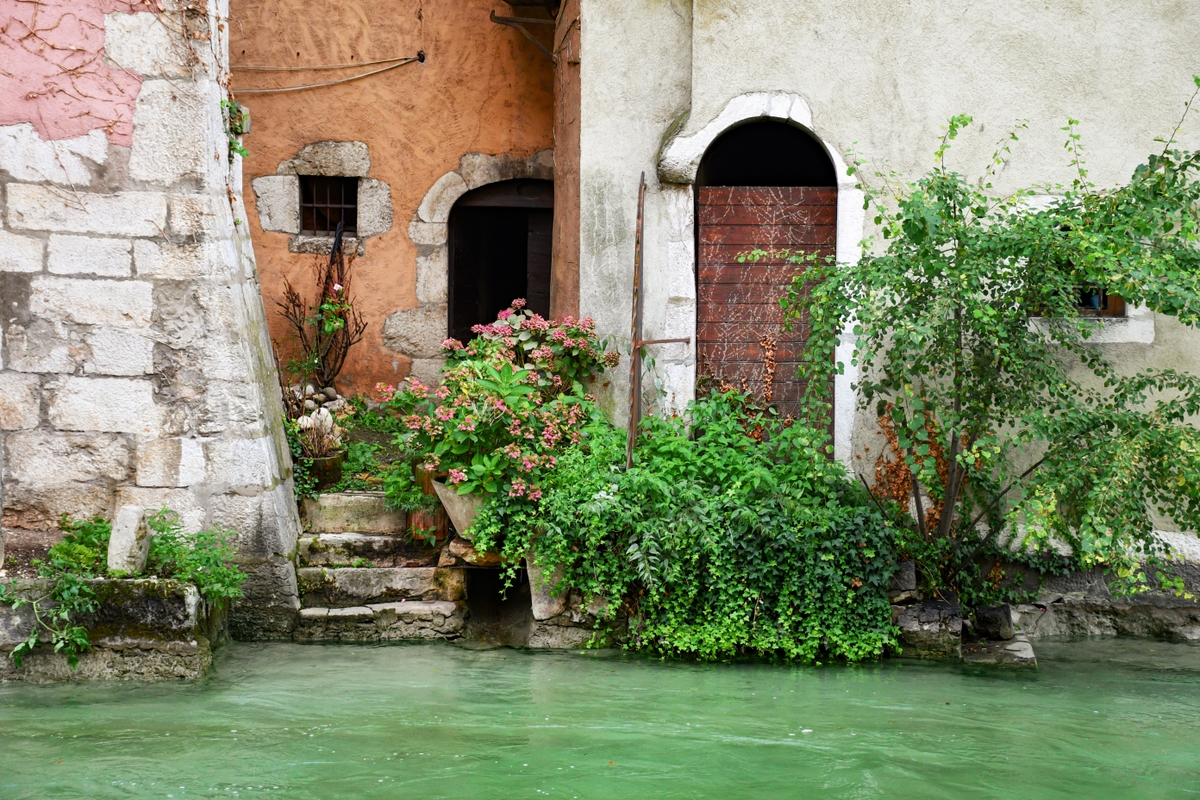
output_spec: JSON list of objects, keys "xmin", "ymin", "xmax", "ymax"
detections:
[{"xmin": 768, "ymin": 90, "xmax": 1200, "ymax": 600}]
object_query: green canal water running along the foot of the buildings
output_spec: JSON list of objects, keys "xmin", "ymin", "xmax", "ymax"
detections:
[{"xmin": 0, "ymin": 640, "xmax": 1200, "ymax": 800}]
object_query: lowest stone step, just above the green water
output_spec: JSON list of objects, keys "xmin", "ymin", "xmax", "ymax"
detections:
[{"xmin": 293, "ymin": 600, "xmax": 466, "ymax": 643}]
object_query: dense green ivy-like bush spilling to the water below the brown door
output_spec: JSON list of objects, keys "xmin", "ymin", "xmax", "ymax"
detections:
[{"xmin": 472, "ymin": 392, "xmax": 899, "ymax": 662}]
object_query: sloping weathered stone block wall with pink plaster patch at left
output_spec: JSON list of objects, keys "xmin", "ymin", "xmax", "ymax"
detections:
[{"xmin": 0, "ymin": 0, "xmax": 299, "ymax": 636}]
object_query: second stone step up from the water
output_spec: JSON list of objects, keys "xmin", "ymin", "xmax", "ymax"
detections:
[{"xmin": 296, "ymin": 567, "xmax": 467, "ymax": 608}]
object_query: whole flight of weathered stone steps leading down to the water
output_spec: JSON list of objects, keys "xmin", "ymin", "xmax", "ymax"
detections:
[{"xmin": 294, "ymin": 492, "xmax": 467, "ymax": 642}]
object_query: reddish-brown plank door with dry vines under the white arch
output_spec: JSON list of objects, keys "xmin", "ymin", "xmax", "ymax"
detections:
[{"xmin": 696, "ymin": 186, "xmax": 838, "ymax": 415}]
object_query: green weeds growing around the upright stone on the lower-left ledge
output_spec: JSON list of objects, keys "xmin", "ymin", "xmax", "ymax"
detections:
[{"xmin": 0, "ymin": 509, "xmax": 246, "ymax": 669}]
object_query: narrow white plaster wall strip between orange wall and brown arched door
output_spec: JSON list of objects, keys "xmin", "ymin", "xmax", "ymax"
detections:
[{"xmin": 580, "ymin": 0, "xmax": 695, "ymax": 425}]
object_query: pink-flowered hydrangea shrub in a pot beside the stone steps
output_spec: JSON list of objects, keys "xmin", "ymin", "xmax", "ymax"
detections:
[{"xmin": 379, "ymin": 300, "xmax": 619, "ymax": 501}]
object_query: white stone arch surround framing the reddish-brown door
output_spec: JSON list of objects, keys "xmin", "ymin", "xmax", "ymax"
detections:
[{"xmin": 656, "ymin": 91, "xmax": 865, "ymax": 463}]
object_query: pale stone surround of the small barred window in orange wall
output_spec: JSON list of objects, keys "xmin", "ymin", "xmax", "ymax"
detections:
[{"xmin": 250, "ymin": 140, "xmax": 392, "ymax": 255}]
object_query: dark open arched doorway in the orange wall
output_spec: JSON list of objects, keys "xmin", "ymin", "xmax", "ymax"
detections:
[{"xmin": 449, "ymin": 180, "xmax": 554, "ymax": 342}]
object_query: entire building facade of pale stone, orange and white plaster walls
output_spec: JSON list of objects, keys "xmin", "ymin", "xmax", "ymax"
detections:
[{"xmin": 0, "ymin": 0, "xmax": 1200, "ymax": 636}]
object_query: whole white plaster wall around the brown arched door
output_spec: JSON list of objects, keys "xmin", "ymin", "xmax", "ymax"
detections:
[{"xmin": 581, "ymin": 0, "xmax": 1200, "ymax": 461}]
